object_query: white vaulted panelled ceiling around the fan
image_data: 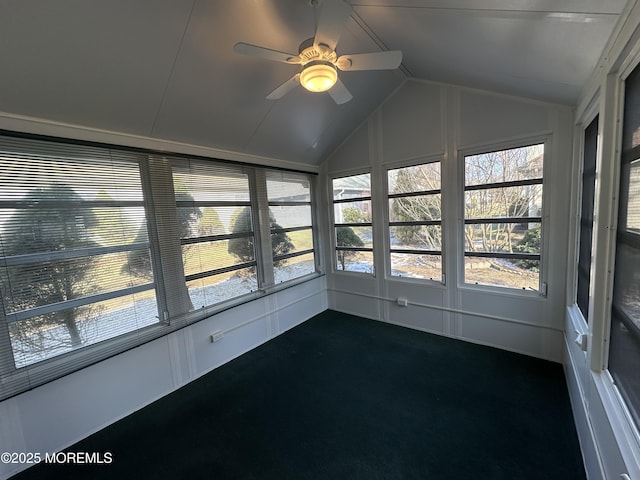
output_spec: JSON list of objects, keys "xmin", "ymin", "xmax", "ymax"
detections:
[{"xmin": 0, "ymin": 0, "xmax": 626, "ymax": 164}]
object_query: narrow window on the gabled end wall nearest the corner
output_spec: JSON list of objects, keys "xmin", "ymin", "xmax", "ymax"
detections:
[{"xmin": 332, "ymin": 173, "xmax": 374, "ymax": 274}]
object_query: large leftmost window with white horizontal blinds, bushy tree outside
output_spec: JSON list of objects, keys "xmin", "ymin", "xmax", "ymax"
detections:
[{"xmin": 0, "ymin": 134, "xmax": 158, "ymax": 396}]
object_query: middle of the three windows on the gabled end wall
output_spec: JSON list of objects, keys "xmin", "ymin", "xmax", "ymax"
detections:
[{"xmin": 387, "ymin": 162, "xmax": 442, "ymax": 281}]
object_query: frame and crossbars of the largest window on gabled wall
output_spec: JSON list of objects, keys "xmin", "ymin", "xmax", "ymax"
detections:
[{"xmin": 458, "ymin": 135, "xmax": 551, "ymax": 297}]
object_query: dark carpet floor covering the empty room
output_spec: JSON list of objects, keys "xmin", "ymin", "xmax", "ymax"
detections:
[{"xmin": 14, "ymin": 310, "xmax": 586, "ymax": 480}]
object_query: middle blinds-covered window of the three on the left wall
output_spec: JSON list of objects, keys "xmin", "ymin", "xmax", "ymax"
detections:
[{"xmin": 172, "ymin": 160, "xmax": 258, "ymax": 309}]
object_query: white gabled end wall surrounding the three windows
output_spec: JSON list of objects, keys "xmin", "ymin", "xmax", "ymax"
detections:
[{"xmin": 320, "ymin": 80, "xmax": 572, "ymax": 362}]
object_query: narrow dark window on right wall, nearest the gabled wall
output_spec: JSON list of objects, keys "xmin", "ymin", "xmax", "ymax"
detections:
[{"xmin": 576, "ymin": 117, "xmax": 598, "ymax": 320}]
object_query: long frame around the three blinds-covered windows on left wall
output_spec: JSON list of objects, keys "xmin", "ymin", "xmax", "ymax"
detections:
[{"xmin": 0, "ymin": 131, "xmax": 321, "ymax": 401}]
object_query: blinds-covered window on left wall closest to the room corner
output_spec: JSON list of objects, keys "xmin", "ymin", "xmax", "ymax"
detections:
[{"xmin": 266, "ymin": 171, "xmax": 316, "ymax": 283}]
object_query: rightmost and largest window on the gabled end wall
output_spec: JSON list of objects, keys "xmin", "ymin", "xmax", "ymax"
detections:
[{"xmin": 464, "ymin": 144, "xmax": 544, "ymax": 291}]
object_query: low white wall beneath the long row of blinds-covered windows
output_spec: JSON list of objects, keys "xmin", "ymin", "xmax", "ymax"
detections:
[{"xmin": 0, "ymin": 277, "xmax": 327, "ymax": 478}]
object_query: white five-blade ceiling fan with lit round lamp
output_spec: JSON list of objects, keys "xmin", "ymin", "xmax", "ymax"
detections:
[{"xmin": 233, "ymin": 0, "xmax": 402, "ymax": 104}]
